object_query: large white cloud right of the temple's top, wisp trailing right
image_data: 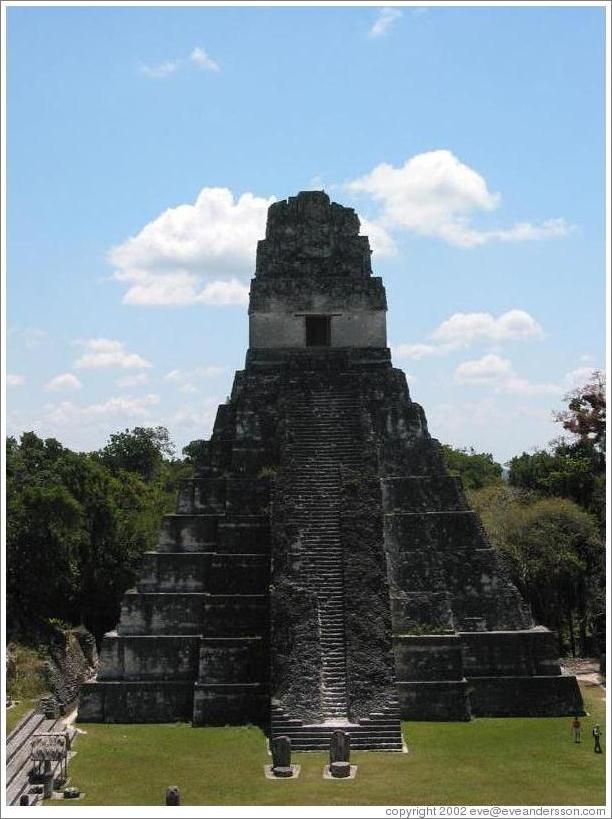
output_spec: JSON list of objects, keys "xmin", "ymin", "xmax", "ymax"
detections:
[{"xmin": 347, "ymin": 149, "xmax": 572, "ymax": 248}]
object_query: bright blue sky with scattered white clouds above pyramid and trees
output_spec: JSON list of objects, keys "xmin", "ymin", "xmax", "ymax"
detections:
[{"xmin": 6, "ymin": 5, "xmax": 605, "ymax": 460}]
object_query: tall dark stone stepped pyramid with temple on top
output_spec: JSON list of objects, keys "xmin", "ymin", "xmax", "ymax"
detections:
[{"xmin": 79, "ymin": 191, "xmax": 582, "ymax": 750}]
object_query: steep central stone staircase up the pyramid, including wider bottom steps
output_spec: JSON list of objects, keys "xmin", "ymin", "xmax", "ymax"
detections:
[{"xmin": 272, "ymin": 384, "xmax": 402, "ymax": 750}]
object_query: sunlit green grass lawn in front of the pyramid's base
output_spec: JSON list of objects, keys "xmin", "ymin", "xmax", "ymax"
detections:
[{"xmin": 53, "ymin": 686, "xmax": 607, "ymax": 810}]
